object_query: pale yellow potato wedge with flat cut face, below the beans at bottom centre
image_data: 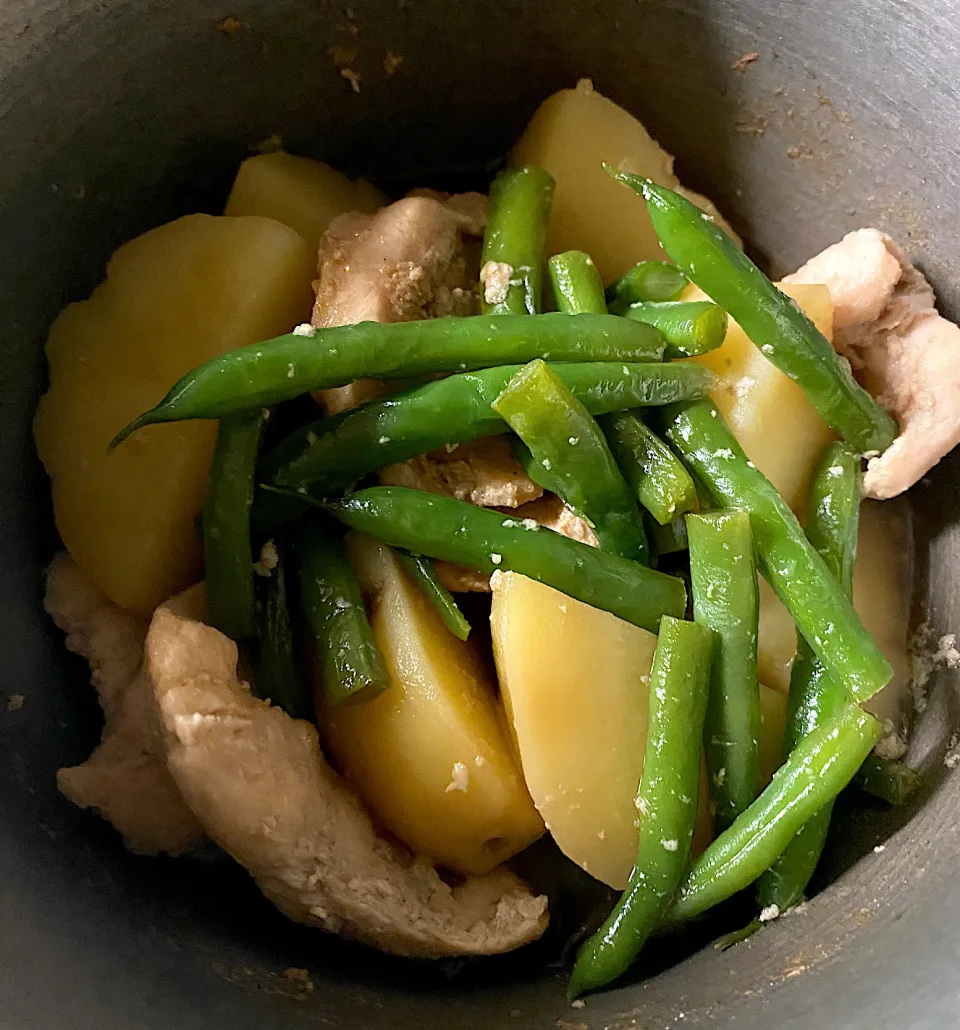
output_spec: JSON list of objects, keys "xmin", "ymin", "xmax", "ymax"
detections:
[{"xmin": 490, "ymin": 573, "xmax": 709, "ymax": 888}]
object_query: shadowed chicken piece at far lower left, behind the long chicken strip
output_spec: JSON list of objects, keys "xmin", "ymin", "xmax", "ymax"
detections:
[{"xmin": 44, "ymin": 554, "xmax": 204, "ymax": 855}]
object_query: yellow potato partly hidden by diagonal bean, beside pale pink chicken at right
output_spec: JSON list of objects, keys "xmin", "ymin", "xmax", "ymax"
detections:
[{"xmin": 685, "ymin": 284, "xmax": 833, "ymax": 512}]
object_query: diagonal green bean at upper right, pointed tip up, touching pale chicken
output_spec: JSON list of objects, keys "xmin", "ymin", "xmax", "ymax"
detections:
[{"xmin": 607, "ymin": 166, "xmax": 896, "ymax": 453}]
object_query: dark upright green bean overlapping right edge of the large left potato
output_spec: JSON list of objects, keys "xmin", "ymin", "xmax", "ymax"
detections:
[{"xmin": 203, "ymin": 410, "xmax": 265, "ymax": 641}]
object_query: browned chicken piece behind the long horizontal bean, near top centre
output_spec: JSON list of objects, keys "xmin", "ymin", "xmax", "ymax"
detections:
[{"xmin": 311, "ymin": 194, "xmax": 486, "ymax": 415}]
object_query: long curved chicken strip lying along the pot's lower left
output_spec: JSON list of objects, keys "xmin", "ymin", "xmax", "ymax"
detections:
[{"xmin": 146, "ymin": 608, "xmax": 547, "ymax": 958}]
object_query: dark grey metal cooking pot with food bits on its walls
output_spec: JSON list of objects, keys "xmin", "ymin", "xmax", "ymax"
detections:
[{"xmin": 0, "ymin": 0, "xmax": 960, "ymax": 1030}]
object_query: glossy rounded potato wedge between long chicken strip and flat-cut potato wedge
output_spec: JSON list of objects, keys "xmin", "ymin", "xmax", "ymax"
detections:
[{"xmin": 323, "ymin": 534, "xmax": 544, "ymax": 874}]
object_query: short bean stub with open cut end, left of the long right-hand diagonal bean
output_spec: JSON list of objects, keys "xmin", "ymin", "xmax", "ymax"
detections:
[{"xmin": 599, "ymin": 411, "xmax": 697, "ymax": 525}]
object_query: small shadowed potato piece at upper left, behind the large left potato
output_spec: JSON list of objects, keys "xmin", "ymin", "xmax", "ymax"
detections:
[{"xmin": 224, "ymin": 150, "xmax": 386, "ymax": 249}]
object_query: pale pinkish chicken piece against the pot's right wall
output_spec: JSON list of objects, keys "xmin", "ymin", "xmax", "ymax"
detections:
[{"xmin": 785, "ymin": 229, "xmax": 960, "ymax": 500}]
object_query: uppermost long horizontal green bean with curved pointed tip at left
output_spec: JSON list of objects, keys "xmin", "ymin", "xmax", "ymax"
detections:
[{"xmin": 111, "ymin": 312, "xmax": 663, "ymax": 446}]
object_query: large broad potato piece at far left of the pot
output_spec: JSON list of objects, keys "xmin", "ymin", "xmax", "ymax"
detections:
[{"xmin": 34, "ymin": 214, "xmax": 315, "ymax": 614}]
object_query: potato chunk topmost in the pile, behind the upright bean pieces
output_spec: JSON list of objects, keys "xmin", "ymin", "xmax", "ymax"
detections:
[{"xmin": 511, "ymin": 78, "xmax": 726, "ymax": 283}]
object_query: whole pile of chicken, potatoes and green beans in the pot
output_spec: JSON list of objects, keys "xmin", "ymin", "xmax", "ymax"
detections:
[{"xmin": 35, "ymin": 81, "xmax": 943, "ymax": 996}]
